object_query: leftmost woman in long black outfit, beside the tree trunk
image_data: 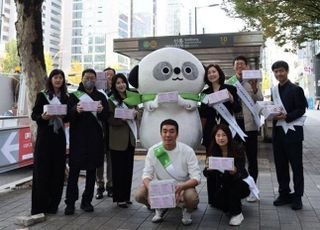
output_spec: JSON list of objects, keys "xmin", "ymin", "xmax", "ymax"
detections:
[{"xmin": 31, "ymin": 69, "xmax": 68, "ymax": 215}]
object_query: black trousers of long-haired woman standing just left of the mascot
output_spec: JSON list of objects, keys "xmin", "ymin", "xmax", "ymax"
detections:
[{"xmin": 110, "ymin": 144, "xmax": 134, "ymax": 202}]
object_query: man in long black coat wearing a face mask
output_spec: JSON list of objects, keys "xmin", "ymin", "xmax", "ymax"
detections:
[{"xmin": 65, "ymin": 69, "xmax": 108, "ymax": 215}]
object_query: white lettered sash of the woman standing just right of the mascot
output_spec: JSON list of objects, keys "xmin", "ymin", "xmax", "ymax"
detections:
[{"xmin": 201, "ymin": 94, "xmax": 247, "ymax": 141}]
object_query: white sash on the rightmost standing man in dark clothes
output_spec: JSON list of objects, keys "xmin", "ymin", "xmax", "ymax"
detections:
[{"xmin": 272, "ymin": 85, "xmax": 307, "ymax": 133}]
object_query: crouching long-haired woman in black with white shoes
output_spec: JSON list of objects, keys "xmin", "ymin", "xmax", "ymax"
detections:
[{"xmin": 203, "ymin": 124, "xmax": 250, "ymax": 225}]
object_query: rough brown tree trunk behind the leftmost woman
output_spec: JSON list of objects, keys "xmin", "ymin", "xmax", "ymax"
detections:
[{"xmin": 15, "ymin": 0, "xmax": 46, "ymax": 142}]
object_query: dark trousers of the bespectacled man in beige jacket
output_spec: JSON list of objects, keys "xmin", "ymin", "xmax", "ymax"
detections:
[{"xmin": 244, "ymin": 131, "xmax": 258, "ymax": 182}]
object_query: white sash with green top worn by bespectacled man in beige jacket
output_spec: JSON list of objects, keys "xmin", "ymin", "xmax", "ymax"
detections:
[{"xmin": 228, "ymin": 76, "xmax": 262, "ymax": 127}]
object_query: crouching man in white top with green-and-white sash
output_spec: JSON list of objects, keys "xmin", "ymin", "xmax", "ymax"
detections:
[{"xmin": 135, "ymin": 119, "xmax": 201, "ymax": 225}]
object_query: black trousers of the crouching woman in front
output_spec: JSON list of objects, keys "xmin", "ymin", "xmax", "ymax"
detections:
[{"xmin": 212, "ymin": 173, "xmax": 250, "ymax": 216}]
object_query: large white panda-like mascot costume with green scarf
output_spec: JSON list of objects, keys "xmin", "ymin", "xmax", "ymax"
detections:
[{"xmin": 129, "ymin": 48, "xmax": 205, "ymax": 149}]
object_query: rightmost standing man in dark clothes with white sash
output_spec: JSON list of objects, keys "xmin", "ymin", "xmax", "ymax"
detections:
[{"xmin": 271, "ymin": 61, "xmax": 307, "ymax": 210}]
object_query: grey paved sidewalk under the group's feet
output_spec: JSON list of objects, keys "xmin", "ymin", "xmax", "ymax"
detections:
[{"xmin": 0, "ymin": 111, "xmax": 320, "ymax": 230}]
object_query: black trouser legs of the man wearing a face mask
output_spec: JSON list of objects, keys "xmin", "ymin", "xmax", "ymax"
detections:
[{"xmin": 65, "ymin": 167, "xmax": 96, "ymax": 205}]
